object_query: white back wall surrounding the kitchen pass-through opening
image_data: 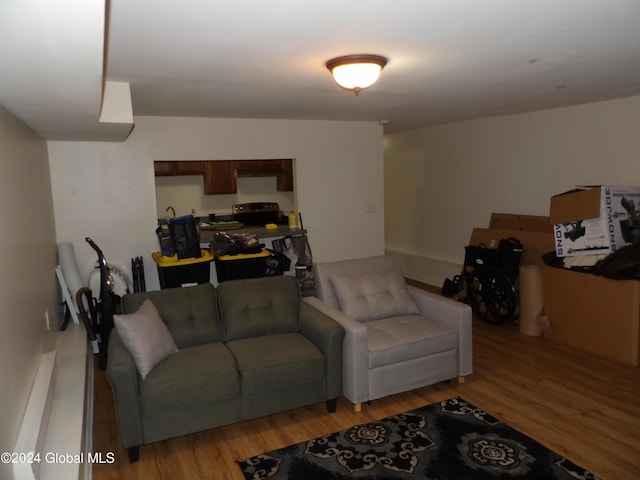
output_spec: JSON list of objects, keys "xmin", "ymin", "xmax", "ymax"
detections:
[{"xmin": 49, "ymin": 117, "xmax": 384, "ymax": 289}]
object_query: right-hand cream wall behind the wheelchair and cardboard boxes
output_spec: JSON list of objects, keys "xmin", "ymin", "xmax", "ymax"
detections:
[{"xmin": 384, "ymin": 96, "xmax": 640, "ymax": 285}]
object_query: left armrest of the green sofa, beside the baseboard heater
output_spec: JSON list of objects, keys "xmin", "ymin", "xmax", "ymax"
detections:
[{"xmin": 107, "ymin": 329, "xmax": 144, "ymax": 448}]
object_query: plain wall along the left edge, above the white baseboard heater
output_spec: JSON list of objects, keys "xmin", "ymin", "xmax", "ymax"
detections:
[{"xmin": 0, "ymin": 107, "xmax": 60, "ymax": 479}]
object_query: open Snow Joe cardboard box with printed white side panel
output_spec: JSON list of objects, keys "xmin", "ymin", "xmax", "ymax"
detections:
[{"xmin": 550, "ymin": 185, "xmax": 640, "ymax": 257}]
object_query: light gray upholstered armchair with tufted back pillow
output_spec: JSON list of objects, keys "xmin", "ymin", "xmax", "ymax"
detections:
[{"xmin": 305, "ymin": 255, "xmax": 473, "ymax": 411}]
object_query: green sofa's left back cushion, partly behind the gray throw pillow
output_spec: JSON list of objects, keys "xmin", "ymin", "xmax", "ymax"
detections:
[{"xmin": 122, "ymin": 283, "xmax": 224, "ymax": 348}]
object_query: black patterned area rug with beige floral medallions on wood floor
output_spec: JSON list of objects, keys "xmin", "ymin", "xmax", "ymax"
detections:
[{"xmin": 238, "ymin": 397, "xmax": 597, "ymax": 480}]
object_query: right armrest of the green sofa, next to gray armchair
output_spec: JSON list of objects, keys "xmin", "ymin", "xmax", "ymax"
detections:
[{"xmin": 300, "ymin": 302, "xmax": 344, "ymax": 400}]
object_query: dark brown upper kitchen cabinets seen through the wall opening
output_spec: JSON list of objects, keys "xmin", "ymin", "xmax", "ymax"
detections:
[{"xmin": 153, "ymin": 158, "xmax": 293, "ymax": 195}]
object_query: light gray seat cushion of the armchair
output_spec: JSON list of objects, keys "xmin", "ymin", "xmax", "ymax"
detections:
[{"xmin": 366, "ymin": 315, "xmax": 458, "ymax": 368}]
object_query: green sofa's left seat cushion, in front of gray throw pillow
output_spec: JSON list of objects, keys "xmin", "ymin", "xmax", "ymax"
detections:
[{"xmin": 140, "ymin": 343, "xmax": 240, "ymax": 416}]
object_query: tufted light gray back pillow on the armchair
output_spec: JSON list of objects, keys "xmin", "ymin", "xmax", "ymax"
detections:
[{"xmin": 331, "ymin": 270, "xmax": 420, "ymax": 322}]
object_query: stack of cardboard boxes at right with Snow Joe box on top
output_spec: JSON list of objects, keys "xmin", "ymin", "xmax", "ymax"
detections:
[{"xmin": 544, "ymin": 186, "xmax": 640, "ymax": 366}]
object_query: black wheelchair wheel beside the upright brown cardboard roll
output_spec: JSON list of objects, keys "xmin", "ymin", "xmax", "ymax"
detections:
[{"xmin": 478, "ymin": 267, "xmax": 518, "ymax": 324}]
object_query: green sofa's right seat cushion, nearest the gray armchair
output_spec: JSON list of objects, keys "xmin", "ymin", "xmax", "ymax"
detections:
[{"xmin": 227, "ymin": 333, "xmax": 326, "ymax": 395}]
